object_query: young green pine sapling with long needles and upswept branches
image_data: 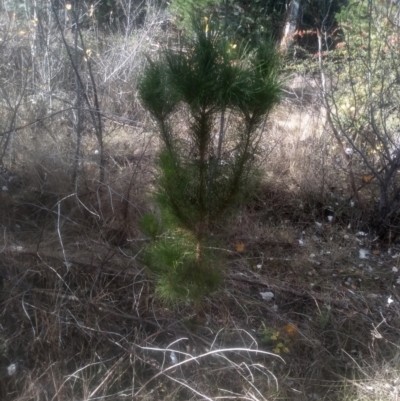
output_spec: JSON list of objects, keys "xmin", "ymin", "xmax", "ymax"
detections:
[{"xmin": 139, "ymin": 14, "xmax": 281, "ymax": 300}]
